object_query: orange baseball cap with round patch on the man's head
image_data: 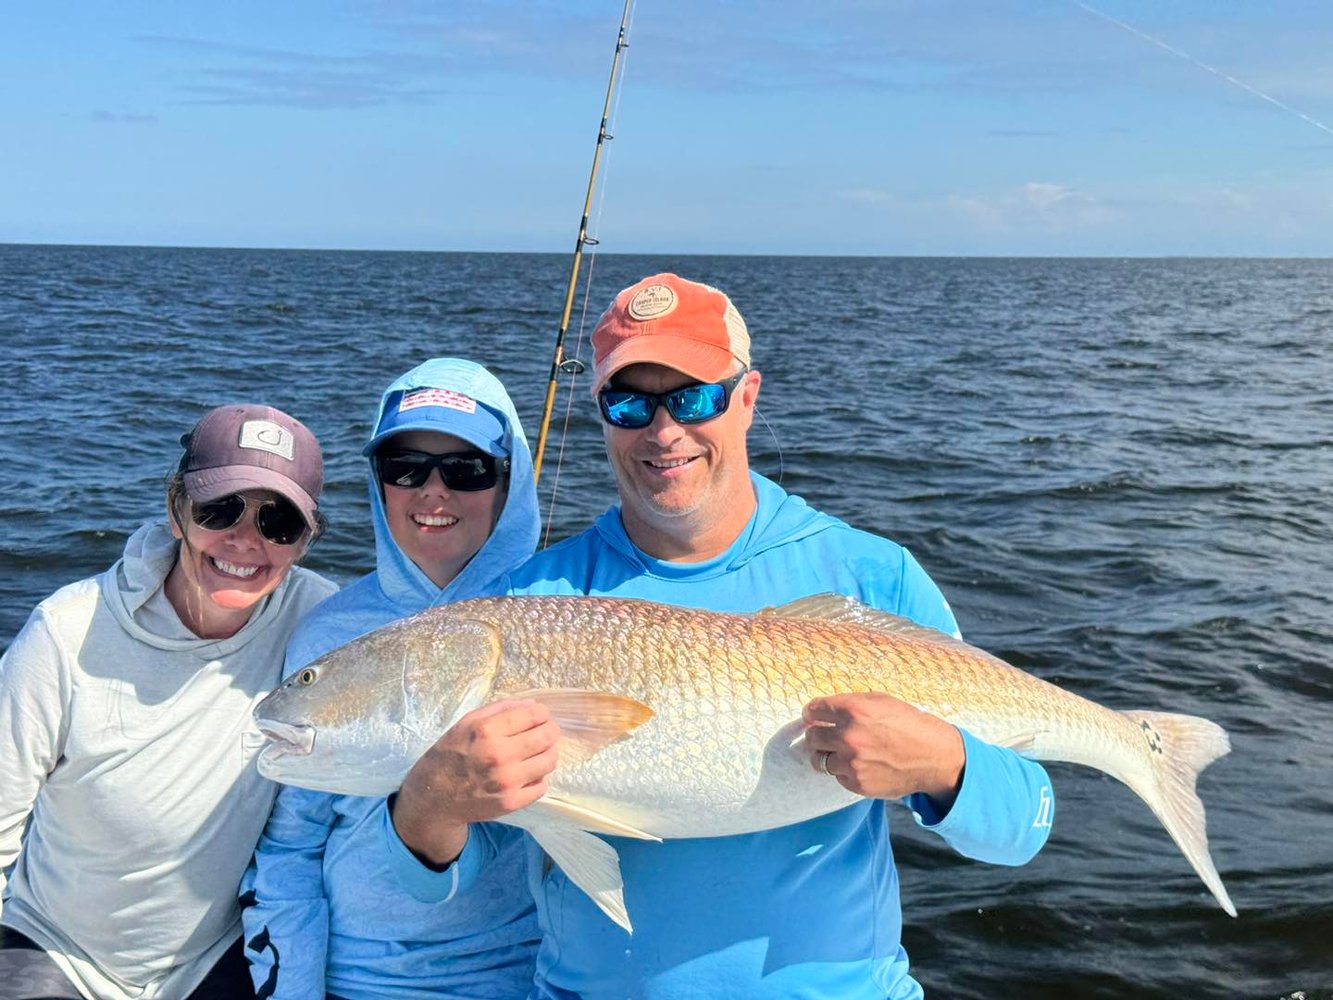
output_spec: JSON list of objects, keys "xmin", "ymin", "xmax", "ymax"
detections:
[{"xmin": 592, "ymin": 273, "xmax": 749, "ymax": 392}]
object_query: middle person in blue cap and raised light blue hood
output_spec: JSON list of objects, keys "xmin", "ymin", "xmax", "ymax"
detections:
[{"xmin": 244, "ymin": 359, "xmax": 539, "ymax": 1000}]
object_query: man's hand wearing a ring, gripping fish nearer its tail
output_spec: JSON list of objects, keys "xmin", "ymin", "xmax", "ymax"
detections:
[{"xmin": 802, "ymin": 692, "xmax": 966, "ymax": 816}]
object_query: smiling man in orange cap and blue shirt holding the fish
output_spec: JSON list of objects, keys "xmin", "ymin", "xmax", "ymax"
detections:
[{"xmin": 393, "ymin": 275, "xmax": 1050, "ymax": 1000}]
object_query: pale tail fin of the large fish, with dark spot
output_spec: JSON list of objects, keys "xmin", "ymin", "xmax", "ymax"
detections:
[{"xmin": 1124, "ymin": 712, "xmax": 1236, "ymax": 916}]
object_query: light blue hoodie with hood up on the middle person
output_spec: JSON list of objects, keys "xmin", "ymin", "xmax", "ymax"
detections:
[{"xmin": 243, "ymin": 359, "xmax": 540, "ymax": 1000}]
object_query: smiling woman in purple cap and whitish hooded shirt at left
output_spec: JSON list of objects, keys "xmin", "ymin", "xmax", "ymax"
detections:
[{"xmin": 0, "ymin": 405, "xmax": 336, "ymax": 1000}]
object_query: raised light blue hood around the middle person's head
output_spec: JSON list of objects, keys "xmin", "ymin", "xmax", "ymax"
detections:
[{"xmin": 287, "ymin": 357, "xmax": 541, "ymax": 672}]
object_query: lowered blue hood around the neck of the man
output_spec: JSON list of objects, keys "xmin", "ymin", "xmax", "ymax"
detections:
[{"xmin": 593, "ymin": 472, "xmax": 838, "ymax": 580}]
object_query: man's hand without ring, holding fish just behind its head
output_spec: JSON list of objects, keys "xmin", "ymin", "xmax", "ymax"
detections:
[{"xmin": 392, "ymin": 700, "xmax": 560, "ymax": 868}]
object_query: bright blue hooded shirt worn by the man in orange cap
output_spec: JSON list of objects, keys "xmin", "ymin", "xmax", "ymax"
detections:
[{"xmin": 389, "ymin": 476, "xmax": 1052, "ymax": 1000}]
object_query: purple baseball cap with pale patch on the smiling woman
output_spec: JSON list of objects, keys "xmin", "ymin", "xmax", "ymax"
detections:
[{"xmin": 180, "ymin": 404, "xmax": 324, "ymax": 532}]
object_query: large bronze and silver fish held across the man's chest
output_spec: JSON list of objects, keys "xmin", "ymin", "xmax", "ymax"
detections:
[{"xmin": 255, "ymin": 593, "xmax": 1236, "ymax": 931}]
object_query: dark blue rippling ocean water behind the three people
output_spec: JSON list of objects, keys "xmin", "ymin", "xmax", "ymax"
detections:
[{"xmin": 0, "ymin": 245, "xmax": 1333, "ymax": 1000}]
